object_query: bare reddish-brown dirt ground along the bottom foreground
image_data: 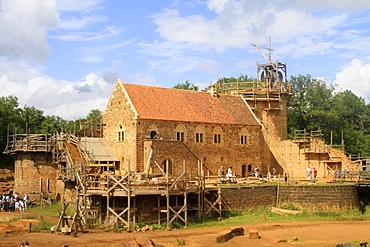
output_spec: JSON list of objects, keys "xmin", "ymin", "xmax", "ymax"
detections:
[{"xmin": 0, "ymin": 212, "xmax": 370, "ymax": 247}]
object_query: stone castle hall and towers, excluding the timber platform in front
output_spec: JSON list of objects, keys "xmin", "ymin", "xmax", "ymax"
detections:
[{"xmin": 5, "ymin": 77, "xmax": 361, "ymax": 197}]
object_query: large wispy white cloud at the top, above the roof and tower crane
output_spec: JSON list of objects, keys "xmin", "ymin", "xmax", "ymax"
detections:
[{"xmin": 153, "ymin": 0, "xmax": 347, "ymax": 51}]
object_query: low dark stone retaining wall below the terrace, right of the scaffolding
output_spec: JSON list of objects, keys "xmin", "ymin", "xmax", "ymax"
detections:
[{"xmin": 222, "ymin": 185, "xmax": 360, "ymax": 211}]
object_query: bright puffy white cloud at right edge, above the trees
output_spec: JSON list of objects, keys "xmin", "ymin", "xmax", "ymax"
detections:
[{"xmin": 334, "ymin": 58, "xmax": 370, "ymax": 102}]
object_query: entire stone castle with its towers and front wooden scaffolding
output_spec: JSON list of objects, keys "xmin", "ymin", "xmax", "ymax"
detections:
[{"xmin": 5, "ymin": 72, "xmax": 361, "ymax": 230}]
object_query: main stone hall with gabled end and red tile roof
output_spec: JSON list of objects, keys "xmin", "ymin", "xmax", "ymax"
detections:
[{"xmin": 103, "ymin": 81, "xmax": 277, "ymax": 177}]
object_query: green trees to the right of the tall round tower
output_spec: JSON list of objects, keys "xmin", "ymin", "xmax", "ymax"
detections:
[{"xmin": 288, "ymin": 75, "xmax": 370, "ymax": 157}]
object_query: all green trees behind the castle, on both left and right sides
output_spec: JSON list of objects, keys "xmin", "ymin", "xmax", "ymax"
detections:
[{"xmin": 0, "ymin": 75, "xmax": 370, "ymax": 165}]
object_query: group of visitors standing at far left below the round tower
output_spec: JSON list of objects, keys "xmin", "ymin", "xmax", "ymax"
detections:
[{"xmin": 0, "ymin": 191, "xmax": 29, "ymax": 213}]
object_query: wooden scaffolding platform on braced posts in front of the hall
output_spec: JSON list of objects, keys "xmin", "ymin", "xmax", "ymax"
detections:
[{"xmin": 58, "ymin": 134, "xmax": 222, "ymax": 230}]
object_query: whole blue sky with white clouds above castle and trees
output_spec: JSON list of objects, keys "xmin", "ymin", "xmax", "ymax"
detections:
[{"xmin": 0, "ymin": 0, "xmax": 370, "ymax": 120}]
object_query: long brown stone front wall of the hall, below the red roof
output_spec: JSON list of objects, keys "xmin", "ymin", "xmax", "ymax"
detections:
[{"xmin": 137, "ymin": 120, "xmax": 270, "ymax": 176}]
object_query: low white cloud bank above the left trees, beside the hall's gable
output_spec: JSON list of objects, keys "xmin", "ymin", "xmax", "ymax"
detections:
[{"xmin": 0, "ymin": 58, "xmax": 114, "ymax": 120}]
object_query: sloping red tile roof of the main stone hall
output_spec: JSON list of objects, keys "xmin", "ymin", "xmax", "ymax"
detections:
[{"xmin": 122, "ymin": 83, "xmax": 260, "ymax": 125}]
